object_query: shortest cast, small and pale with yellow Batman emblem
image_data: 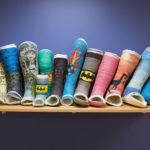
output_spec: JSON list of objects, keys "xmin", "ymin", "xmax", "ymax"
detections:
[{"xmin": 33, "ymin": 75, "xmax": 49, "ymax": 106}]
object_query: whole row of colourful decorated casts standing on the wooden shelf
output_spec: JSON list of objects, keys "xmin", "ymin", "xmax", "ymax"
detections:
[{"xmin": 0, "ymin": 38, "xmax": 150, "ymax": 107}]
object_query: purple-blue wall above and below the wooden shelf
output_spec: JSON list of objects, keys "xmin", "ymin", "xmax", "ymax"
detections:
[{"xmin": 0, "ymin": 0, "xmax": 150, "ymax": 150}]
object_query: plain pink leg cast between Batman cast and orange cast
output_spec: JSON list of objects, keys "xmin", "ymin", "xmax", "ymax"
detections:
[{"xmin": 89, "ymin": 52, "xmax": 119, "ymax": 106}]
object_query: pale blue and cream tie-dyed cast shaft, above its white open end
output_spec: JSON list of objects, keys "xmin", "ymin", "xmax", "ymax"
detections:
[{"xmin": 124, "ymin": 47, "xmax": 150, "ymax": 95}]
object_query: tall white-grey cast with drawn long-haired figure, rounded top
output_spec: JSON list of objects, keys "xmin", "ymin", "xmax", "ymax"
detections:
[{"xmin": 19, "ymin": 41, "xmax": 38, "ymax": 105}]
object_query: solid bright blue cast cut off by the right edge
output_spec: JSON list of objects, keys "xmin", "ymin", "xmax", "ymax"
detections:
[{"xmin": 142, "ymin": 78, "xmax": 150, "ymax": 104}]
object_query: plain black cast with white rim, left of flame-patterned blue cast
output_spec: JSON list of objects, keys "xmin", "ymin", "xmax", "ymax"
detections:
[{"xmin": 46, "ymin": 54, "xmax": 67, "ymax": 106}]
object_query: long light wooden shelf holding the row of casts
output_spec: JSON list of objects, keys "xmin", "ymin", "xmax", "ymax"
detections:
[{"xmin": 0, "ymin": 105, "xmax": 150, "ymax": 113}]
